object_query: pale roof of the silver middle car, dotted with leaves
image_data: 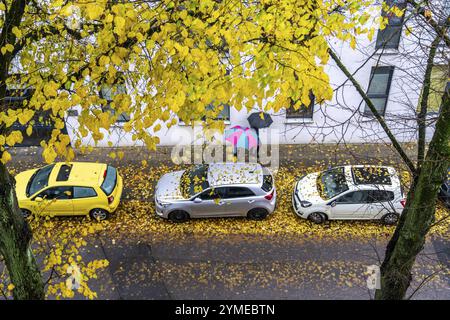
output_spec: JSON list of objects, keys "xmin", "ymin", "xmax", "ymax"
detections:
[{"xmin": 208, "ymin": 162, "xmax": 263, "ymax": 187}]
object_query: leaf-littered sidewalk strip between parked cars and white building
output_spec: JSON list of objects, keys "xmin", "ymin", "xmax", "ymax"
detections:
[{"xmin": 9, "ymin": 144, "xmax": 416, "ymax": 167}]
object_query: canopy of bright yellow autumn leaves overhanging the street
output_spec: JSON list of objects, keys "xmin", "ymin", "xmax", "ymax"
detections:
[{"xmin": 0, "ymin": 0, "xmax": 388, "ymax": 165}]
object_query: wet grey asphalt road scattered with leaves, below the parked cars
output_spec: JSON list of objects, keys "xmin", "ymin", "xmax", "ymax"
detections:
[{"xmin": 5, "ymin": 146, "xmax": 450, "ymax": 299}]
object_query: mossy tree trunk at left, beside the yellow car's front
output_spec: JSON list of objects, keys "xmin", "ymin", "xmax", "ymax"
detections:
[{"xmin": 0, "ymin": 162, "xmax": 45, "ymax": 300}]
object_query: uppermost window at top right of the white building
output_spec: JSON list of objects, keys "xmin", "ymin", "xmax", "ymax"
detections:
[{"xmin": 375, "ymin": 0, "xmax": 406, "ymax": 49}]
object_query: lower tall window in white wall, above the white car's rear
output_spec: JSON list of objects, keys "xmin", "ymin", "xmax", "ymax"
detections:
[{"xmin": 364, "ymin": 66, "xmax": 394, "ymax": 116}]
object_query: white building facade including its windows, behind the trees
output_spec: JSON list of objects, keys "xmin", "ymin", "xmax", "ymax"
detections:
[{"xmin": 66, "ymin": 0, "xmax": 448, "ymax": 146}]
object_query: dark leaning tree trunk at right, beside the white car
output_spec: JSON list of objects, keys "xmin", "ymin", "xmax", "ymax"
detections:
[{"xmin": 375, "ymin": 82, "xmax": 450, "ymax": 300}]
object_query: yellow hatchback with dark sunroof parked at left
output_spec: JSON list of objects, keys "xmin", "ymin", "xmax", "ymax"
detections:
[{"xmin": 15, "ymin": 162, "xmax": 123, "ymax": 220}]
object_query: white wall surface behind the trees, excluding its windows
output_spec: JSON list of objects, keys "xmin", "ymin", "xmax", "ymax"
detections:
[{"xmin": 67, "ymin": 4, "xmax": 431, "ymax": 146}]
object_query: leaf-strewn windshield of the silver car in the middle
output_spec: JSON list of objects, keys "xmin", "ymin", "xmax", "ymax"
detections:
[{"xmin": 180, "ymin": 164, "xmax": 209, "ymax": 199}]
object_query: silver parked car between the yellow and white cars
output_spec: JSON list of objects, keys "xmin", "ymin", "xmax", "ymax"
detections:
[{"xmin": 155, "ymin": 163, "xmax": 276, "ymax": 222}]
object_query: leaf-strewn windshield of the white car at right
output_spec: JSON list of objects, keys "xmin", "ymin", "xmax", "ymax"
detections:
[{"xmin": 317, "ymin": 168, "xmax": 348, "ymax": 200}]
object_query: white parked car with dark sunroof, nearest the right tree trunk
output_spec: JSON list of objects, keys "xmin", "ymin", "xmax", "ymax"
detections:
[{"xmin": 292, "ymin": 165, "xmax": 405, "ymax": 224}]
